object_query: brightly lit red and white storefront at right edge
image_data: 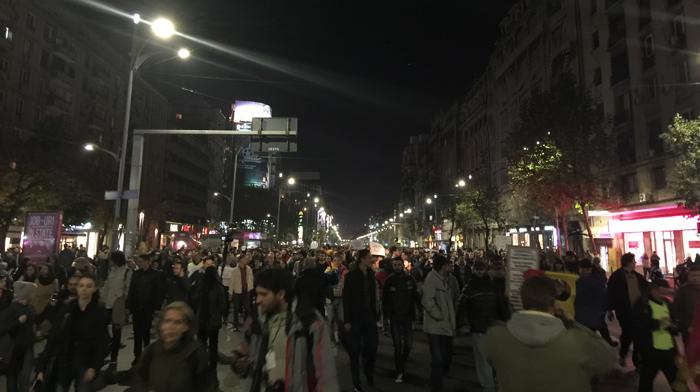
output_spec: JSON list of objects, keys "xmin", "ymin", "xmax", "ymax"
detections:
[{"xmin": 591, "ymin": 204, "xmax": 700, "ymax": 273}]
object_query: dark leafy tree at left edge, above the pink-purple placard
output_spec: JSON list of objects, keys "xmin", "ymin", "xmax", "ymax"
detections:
[{"xmin": 0, "ymin": 118, "xmax": 112, "ymax": 248}]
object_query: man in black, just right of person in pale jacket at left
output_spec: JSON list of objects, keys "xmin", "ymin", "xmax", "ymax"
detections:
[{"xmin": 126, "ymin": 255, "xmax": 163, "ymax": 363}]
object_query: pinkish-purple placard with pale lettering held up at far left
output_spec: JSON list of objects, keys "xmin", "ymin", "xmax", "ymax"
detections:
[{"xmin": 22, "ymin": 211, "xmax": 63, "ymax": 263}]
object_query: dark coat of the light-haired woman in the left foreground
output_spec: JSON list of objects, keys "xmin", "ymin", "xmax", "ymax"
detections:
[{"xmin": 131, "ymin": 338, "xmax": 217, "ymax": 392}]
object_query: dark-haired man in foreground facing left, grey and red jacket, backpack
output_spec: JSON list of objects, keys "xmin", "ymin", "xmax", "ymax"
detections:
[{"xmin": 233, "ymin": 269, "xmax": 340, "ymax": 392}]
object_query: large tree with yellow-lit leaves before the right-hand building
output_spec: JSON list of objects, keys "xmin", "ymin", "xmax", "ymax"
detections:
[{"xmin": 505, "ymin": 73, "xmax": 612, "ymax": 253}]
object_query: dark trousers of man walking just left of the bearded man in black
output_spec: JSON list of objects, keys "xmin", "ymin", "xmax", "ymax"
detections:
[{"xmin": 346, "ymin": 323, "xmax": 379, "ymax": 388}]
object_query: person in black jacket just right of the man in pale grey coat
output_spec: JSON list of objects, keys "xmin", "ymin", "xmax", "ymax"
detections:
[{"xmin": 458, "ymin": 260, "xmax": 510, "ymax": 392}]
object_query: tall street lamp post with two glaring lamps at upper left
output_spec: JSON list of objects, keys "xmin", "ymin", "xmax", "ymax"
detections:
[{"xmin": 112, "ymin": 14, "xmax": 191, "ymax": 249}]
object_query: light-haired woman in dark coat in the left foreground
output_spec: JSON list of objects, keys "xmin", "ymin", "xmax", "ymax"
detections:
[{"xmin": 131, "ymin": 301, "xmax": 217, "ymax": 392}]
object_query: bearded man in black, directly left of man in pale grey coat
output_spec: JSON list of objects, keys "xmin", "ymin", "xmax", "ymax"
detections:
[{"xmin": 382, "ymin": 258, "xmax": 419, "ymax": 383}]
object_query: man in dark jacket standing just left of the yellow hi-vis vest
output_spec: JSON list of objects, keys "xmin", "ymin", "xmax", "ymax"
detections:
[{"xmin": 608, "ymin": 253, "xmax": 649, "ymax": 366}]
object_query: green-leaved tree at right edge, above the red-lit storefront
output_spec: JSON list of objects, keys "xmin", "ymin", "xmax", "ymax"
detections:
[{"xmin": 661, "ymin": 114, "xmax": 700, "ymax": 214}]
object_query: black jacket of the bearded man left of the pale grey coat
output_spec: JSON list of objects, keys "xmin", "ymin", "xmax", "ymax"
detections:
[{"xmin": 382, "ymin": 271, "xmax": 420, "ymax": 322}]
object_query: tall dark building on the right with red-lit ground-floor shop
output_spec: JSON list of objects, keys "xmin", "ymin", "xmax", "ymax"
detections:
[{"xmin": 401, "ymin": 0, "xmax": 700, "ymax": 271}]
